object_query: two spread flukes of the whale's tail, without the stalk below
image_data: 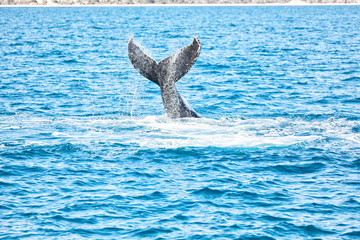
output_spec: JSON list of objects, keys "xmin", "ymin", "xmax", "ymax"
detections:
[{"xmin": 128, "ymin": 36, "xmax": 201, "ymax": 86}]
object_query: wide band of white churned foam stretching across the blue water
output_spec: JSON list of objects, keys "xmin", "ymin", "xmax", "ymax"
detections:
[{"xmin": 2, "ymin": 116, "xmax": 360, "ymax": 148}]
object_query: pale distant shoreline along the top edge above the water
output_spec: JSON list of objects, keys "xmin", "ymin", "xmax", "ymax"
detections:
[{"xmin": 0, "ymin": 0, "xmax": 360, "ymax": 6}]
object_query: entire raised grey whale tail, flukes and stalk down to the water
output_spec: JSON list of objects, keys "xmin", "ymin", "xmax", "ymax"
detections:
[{"xmin": 128, "ymin": 37, "xmax": 202, "ymax": 118}]
